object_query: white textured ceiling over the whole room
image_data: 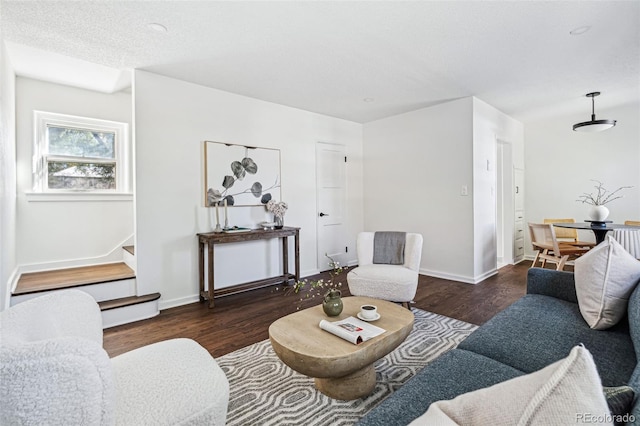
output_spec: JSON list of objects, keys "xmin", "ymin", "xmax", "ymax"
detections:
[{"xmin": 0, "ymin": 0, "xmax": 640, "ymax": 122}]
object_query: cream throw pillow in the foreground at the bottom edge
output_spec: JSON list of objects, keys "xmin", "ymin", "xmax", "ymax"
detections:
[{"xmin": 411, "ymin": 346, "xmax": 613, "ymax": 426}]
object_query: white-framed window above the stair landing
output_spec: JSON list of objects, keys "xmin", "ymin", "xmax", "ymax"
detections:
[{"xmin": 33, "ymin": 111, "xmax": 129, "ymax": 193}]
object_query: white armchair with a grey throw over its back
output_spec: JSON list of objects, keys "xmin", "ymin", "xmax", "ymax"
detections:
[{"xmin": 347, "ymin": 232, "xmax": 422, "ymax": 307}]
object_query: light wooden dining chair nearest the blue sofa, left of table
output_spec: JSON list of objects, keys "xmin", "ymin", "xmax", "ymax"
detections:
[{"xmin": 529, "ymin": 223, "xmax": 589, "ymax": 271}]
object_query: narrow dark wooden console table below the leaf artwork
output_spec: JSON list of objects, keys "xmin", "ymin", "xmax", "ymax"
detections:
[{"xmin": 198, "ymin": 226, "xmax": 300, "ymax": 308}]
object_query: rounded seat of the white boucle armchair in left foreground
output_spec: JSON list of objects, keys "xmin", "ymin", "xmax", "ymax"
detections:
[{"xmin": 111, "ymin": 339, "xmax": 229, "ymax": 426}]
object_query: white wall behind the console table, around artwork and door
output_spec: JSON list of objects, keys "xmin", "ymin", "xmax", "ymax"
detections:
[{"xmin": 134, "ymin": 71, "xmax": 362, "ymax": 309}]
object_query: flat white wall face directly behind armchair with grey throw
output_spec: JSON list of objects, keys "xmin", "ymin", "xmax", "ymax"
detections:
[{"xmin": 363, "ymin": 98, "xmax": 474, "ymax": 280}]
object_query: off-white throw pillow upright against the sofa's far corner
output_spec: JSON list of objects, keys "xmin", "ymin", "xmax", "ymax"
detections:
[{"xmin": 574, "ymin": 236, "xmax": 640, "ymax": 330}]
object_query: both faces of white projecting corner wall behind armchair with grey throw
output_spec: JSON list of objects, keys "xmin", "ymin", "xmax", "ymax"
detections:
[{"xmin": 364, "ymin": 98, "xmax": 523, "ymax": 283}]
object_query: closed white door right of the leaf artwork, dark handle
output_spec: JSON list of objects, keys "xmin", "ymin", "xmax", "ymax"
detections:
[{"xmin": 316, "ymin": 142, "xmax": 347, "ymax": 271}]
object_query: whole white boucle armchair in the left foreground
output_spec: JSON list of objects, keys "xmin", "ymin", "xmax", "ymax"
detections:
[{"xmin": 0, "ymin": 290, "xmax": 229, "ymax": 425}]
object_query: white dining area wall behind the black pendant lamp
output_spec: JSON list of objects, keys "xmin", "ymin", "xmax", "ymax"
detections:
[{"xmin": 524, "ymin": 97, "xmax": 640, "ymax": 256}]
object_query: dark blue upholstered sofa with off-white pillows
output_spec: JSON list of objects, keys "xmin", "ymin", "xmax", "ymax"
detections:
[{"xmin": 358, "ymin": 268, "xmax": 640, "ymax": 426}]
